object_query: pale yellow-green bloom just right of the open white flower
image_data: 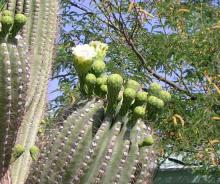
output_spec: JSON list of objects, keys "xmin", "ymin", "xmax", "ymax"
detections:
[{"xmin": 89, "ymin": 41, "xmax": 108, "ymax": 61}]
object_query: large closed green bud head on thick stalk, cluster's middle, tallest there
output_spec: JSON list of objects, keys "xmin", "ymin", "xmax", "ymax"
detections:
[{"xmin": 107, "ymin": 74, "xmax": 123, "ymax": 93}]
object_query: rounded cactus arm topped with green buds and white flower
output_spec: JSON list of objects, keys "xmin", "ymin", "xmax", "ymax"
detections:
[{"xmin": 26, "ymin": 41, "xmax": 171, "ymax": 184}]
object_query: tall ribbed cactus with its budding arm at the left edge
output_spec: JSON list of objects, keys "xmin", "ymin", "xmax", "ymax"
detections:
[{"xmin": 0, "ymin": 0, "xmax": 58, "ymax": 184}]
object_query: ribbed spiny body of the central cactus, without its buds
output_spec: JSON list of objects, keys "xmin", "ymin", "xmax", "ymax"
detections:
[{"xmin": 26, "ymin": 99, "xmax": 158, "ymax": 184}]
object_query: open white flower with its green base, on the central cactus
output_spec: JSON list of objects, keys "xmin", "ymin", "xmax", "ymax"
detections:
[{"xmin": 72, "ymin": 44, "xmax": 96, "ymax": 76}]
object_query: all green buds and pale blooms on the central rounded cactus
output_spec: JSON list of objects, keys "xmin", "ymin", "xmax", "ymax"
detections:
[{"xmin": 72, "ymin": 41, "xmax": 171, "ymax": 146}]
